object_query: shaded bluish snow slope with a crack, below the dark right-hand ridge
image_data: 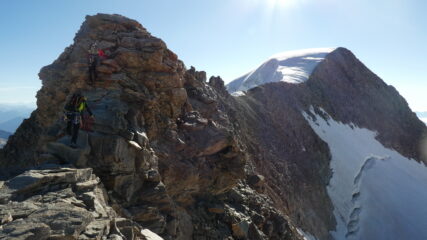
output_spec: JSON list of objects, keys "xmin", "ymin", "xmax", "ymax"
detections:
[{"xmin": 304, "ymin": 109, "xmax": 427, "ymax": 240}]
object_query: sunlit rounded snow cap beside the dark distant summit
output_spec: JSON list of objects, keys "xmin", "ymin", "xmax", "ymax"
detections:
[{"xmin": 227, "ymin": 48, "xmax": 335, "ymax": 93}]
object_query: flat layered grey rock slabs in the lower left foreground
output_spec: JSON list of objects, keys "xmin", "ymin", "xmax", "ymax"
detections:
[{"xmin": 0, "ymin": 166, "xmax": 162, "ymax": 239}]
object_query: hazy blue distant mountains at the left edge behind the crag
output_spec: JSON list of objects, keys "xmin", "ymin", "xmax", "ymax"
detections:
[{"xmin": 0, "ymin": 103, "xmax": 35, "ymax": 133}]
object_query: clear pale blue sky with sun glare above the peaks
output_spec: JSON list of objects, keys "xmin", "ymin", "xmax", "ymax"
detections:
[{"xmin": 0, "ymin": 0, "xmax": 427, "ymax": 111}]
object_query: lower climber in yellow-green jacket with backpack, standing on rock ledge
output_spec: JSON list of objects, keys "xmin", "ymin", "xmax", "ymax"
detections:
[{"xmin": 64, "ymin": 93, "xmax": 95, "ymax": 148}]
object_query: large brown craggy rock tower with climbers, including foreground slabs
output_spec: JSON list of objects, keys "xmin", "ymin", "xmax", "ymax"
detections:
[{"xmin": 0, "ymin": 14, "xmax": 300, "ymax": 239}]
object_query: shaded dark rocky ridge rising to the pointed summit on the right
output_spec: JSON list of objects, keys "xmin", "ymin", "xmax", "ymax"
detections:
[{"xmin": 224, "ymin": 48, "xmax": 427, "ymax": 239}]
